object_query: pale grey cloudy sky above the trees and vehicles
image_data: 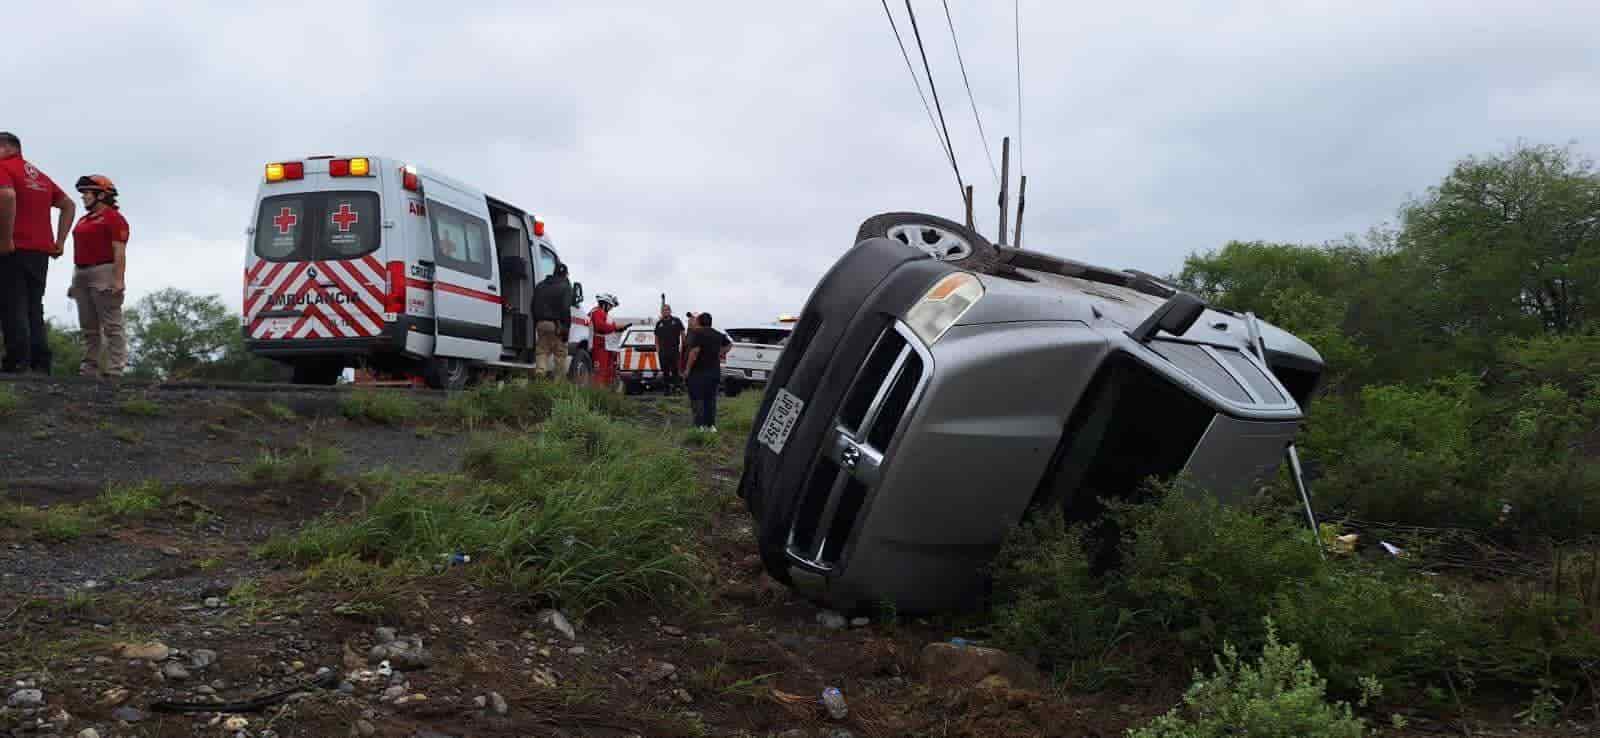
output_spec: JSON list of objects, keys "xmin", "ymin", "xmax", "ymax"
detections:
[{"xmin": 0, "ymin": 0, "xmax": 1600, "ymax": 327}]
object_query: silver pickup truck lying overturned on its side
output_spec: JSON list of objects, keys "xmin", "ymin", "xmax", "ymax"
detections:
[{"xmin": 739, "ymin": 213, "xmax": 1323, "ymax": 612}]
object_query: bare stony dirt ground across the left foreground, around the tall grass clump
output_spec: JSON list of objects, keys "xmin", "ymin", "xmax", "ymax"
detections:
[{"xmin": 0, "ymin": 381, "xmax": 1586, "ymax": 738}]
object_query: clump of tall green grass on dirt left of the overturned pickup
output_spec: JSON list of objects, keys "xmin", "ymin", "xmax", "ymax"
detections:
[{"xmin": 264, "ymin": 386, "xmax": 709, "ymax": 613}]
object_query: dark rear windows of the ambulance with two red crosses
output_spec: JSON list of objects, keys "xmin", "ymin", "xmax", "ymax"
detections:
[{"xmin": 254, "ymin": 192, "xmax": 379, "ymax": 261}]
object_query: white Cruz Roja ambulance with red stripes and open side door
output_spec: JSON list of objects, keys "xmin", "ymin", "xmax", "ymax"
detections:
[{"xmin": 233, "ymin": 155, "xmax": 589, "ymax": 389}]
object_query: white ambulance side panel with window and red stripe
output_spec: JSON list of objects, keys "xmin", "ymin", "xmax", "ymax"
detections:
[{"xmin": 427, "ymin": 194, "xmax": 501, "ymax": 362}]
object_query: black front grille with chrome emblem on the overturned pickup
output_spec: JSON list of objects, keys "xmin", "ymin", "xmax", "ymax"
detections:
[{"xmin": 787, "ymin": 323, "xmax": 928, "ymax": 570}]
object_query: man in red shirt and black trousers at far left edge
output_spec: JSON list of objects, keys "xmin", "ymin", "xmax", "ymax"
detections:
[{"xmin": 0, "ymin": 133, "xmax": 77, "ymax": 375}]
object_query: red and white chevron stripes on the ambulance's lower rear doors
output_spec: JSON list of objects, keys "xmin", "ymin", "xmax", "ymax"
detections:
[{"xmin": 245, "ymin": 255, "xmax": 389, "ymax": 339}]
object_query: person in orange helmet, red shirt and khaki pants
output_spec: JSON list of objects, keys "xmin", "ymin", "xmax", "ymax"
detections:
[{"xmin": 67, "ymin": 174, "xmax": 128, "ymax": 376}]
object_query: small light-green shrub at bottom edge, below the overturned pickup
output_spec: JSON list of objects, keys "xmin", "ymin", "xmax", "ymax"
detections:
[{"xmin": 1128, "ymin": 620, "xmax": 1363, "ymax": 738}]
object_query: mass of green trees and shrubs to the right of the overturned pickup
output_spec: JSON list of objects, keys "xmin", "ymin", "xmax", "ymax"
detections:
[{"xmin": 966, "ymin": 146, "xmax": 1600, "ymax": 726}]
